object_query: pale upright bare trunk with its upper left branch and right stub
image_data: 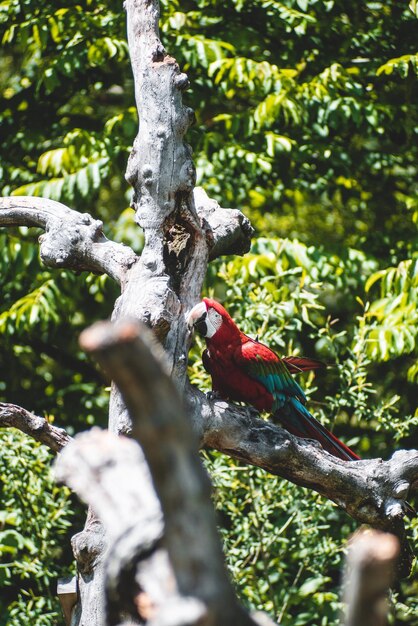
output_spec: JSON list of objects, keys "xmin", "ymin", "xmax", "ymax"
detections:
[{"xmin": 0, "ymin": 0, "xmax": 252, "ymax": 626}]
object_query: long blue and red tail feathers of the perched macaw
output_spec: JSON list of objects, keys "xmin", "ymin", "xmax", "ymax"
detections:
[{"xmin": 273, "ymin": 398, "xmax": 360, "ymax": 461}]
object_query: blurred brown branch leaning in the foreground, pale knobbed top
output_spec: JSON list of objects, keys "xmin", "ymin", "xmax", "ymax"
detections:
[{"xmin": 80, "ymin": 320, "xmax": 254, "ymax": 626}]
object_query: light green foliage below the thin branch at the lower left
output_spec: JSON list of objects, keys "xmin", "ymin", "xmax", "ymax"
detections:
[{"xmin": 0, "ymin": 430, "xmax": 74, "ymax": 626}]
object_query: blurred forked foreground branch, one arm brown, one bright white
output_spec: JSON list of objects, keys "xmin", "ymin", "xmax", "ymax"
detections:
[{"xmin": 57, "ymin": 321, "xmax": 256, "ymax": 626}]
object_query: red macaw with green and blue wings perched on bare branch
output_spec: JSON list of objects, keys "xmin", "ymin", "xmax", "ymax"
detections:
[{"xmin": 187, "ymin": 298, "xmax": 360, "ymax": 461}]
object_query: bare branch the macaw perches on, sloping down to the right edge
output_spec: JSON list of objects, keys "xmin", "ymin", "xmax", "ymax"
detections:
[{"xmin": 187, "ymin": 387, "xmax": 418, "ymax": 575}]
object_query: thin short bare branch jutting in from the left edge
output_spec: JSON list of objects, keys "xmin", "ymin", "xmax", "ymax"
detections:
[{"xmin": 0, "ymin": 402, "xmax": 72, "ymax": 452}]
